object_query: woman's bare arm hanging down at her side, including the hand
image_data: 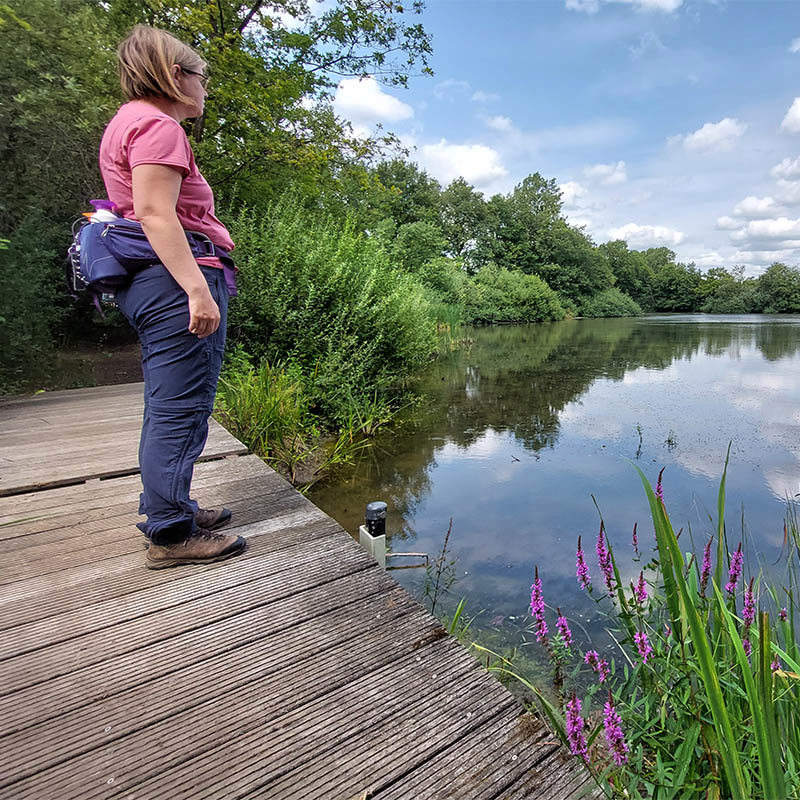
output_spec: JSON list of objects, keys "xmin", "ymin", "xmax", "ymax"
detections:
[{"xmin": 131, "ymin": 164, "xmax": 219, "ymax": 339}]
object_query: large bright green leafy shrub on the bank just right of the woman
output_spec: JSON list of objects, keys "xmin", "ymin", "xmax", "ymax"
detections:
[{"xmin": 225, "ymin": 195, "xmax": 436, "ymax": 422}]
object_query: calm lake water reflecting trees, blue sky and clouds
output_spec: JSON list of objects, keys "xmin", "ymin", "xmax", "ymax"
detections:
[{"xmin": 311, "ymin": 314, "xmax": 800, "ymax": 652}]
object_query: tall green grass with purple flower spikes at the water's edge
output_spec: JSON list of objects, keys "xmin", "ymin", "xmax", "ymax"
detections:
[{"xmin": 484, "ymin": 460, "xmax": 800, "ymax": 800}]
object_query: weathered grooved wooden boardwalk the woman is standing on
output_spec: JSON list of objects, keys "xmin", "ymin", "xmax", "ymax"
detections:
[{"xmin": 0, "ymin": 384, "xmax": 593, "ymax": 800}]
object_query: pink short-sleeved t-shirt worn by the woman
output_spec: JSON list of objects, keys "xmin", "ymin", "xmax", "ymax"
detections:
[{"xmin": 100, "ymin": 100, "xmax": 233, "ymax": 267}]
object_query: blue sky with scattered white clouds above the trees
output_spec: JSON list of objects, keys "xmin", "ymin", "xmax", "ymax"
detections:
[{"xmin": 326, "ymin": 0, "xmax": 800, "ymax": 275}]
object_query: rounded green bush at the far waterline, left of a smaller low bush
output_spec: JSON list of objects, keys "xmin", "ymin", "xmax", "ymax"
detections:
[{"xmin": 464, "ymin": 265, "xmax": 564, "ymax": 323}]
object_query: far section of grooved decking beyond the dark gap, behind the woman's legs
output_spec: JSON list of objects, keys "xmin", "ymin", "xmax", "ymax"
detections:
[{"xmin": 0, "ymin": 383, "xmax": 247, "ymax": 495}]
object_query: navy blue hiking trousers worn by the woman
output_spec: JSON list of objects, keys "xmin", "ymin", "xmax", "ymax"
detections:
[{"xmin": 116, "ymin": 264, "xmax": 228, "ymax": 543}]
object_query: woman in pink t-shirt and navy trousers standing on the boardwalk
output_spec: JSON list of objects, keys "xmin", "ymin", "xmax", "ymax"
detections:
[{"xmin": 100, "ymin": 25, "xmax": 245, "ymax": 569}]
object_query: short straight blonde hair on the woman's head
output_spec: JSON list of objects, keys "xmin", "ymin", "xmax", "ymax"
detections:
[{"xmin": 117, "ymin": 25, "xmax": 206, "ymax": 103}]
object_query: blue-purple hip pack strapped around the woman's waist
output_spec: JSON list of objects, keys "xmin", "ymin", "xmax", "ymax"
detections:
[{"xmin": 67, "ymin": 216, "xmax": 233, "ymax": 294}]
